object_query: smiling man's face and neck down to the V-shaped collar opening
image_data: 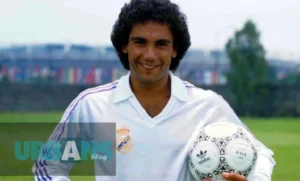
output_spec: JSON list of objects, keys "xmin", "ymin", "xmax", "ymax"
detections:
[{"xmin": 122, "ymin": 21, "xmax": 177, "ymax": 117}]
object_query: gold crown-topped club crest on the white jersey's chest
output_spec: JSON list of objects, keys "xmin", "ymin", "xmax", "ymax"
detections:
[{"xmin": 116, "ymin": 127, "xmax": 133, "ymax": 154}]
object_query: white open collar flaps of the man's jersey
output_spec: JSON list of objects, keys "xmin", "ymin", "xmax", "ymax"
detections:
[{"xmin": 113, "ymin": 71, "xmax": 188, "ymax": 103}]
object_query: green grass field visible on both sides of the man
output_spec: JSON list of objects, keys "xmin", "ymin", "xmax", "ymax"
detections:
[{"xmin": 0, "ymin": 113, "xmax": 300, "ymax": 181}]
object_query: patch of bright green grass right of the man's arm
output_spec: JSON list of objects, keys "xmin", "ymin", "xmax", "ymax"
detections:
[{"xmin": 245, "ymin": 118, "xmax": 300, "ymax": 181}]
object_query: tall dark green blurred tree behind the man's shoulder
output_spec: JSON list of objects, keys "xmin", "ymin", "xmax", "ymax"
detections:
[{"xmin": 226, "ymin": 20, "xmax": 268, "ymax": 115}]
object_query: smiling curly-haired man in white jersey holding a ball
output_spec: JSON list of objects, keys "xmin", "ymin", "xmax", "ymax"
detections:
[{"xmin": 34, "ymin": 0, "xmax": 275, "ymax": 181}]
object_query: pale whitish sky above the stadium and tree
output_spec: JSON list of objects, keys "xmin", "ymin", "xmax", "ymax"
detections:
[{"xmin": 0, "ymin": 0, "xmax": 300, "ymax": 62}]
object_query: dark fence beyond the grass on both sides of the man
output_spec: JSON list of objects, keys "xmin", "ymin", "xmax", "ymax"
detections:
[{"xmin": 0, "ymin": 83, "xmax": 300, "ymax": 116}]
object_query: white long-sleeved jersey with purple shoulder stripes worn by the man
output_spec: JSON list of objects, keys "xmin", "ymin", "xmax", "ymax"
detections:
[{"xmin": 34, "ymin": 72, "xmax": 275, "ymax": 181}]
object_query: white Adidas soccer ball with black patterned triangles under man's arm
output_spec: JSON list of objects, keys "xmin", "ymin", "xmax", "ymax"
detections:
[{"xmin": 188, "ymin": 122, "xmax": 257, "ymax": 181}]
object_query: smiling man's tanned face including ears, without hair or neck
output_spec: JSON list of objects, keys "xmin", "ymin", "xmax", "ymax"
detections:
[{"xmin": 123, "ymin": 21, "xmax": 177, "ymax": 84}]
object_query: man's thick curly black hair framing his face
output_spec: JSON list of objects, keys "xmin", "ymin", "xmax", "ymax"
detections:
[{"xmin": 111, "ymin": 0, "xmax": 191, "ymax": 71}]
